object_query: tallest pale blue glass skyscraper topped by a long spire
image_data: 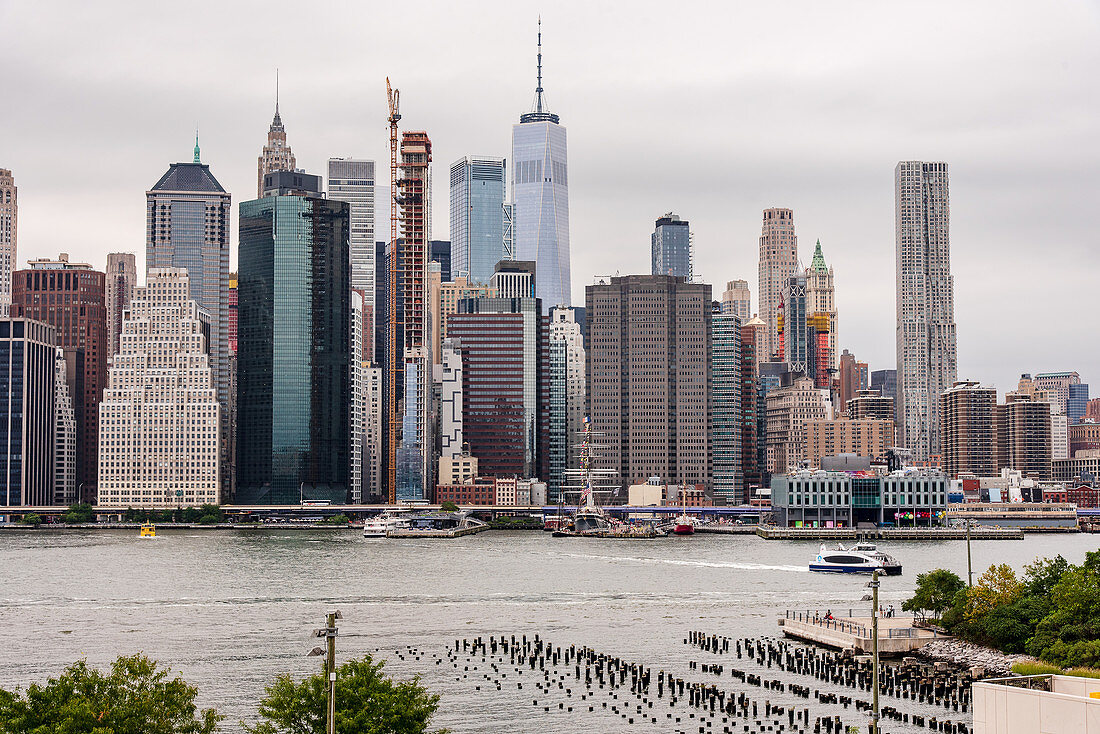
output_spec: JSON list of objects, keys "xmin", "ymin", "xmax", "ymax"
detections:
[{"xmin": 512, "ymin": 22, "xmax": 572, "ymax": 310}]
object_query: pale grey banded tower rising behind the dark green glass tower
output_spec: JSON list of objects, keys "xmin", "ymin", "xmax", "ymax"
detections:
[{"xmin": 328, "ymin": 158, "xmax": 375, "ymax": 316}]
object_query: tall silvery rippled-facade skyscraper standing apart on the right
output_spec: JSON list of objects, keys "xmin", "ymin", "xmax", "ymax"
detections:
[{"xmin": 897, "ymin": 161, "xmax": 957, "ymax": 460}]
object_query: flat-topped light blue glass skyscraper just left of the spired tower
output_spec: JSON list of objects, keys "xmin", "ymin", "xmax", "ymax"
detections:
[{"xmin": 451, "ymin": 156, "xmax": 512, "ymax": 284}]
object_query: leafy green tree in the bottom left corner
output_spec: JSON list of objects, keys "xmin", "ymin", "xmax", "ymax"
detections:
[{"xmin": 0, "ymin": 655, "xmax": 221, "ymax": 734}]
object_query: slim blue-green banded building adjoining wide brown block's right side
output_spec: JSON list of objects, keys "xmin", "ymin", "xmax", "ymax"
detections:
[{"xmin": 711, "ymin": 313, "xmax": 745, "ymax": 505}]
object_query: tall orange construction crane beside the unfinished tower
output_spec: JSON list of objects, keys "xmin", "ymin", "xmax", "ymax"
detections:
[{"xmin": 385, "ymin": 77, "xmax": 402, "ymax": 505}]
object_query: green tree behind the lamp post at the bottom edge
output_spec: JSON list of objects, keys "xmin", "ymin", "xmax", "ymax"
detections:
[{"xmin": 244, "ymin": 655, "xmax": 442, "ymax": 734}]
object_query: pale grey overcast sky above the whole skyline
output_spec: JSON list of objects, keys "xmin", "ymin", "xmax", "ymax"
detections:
[{"xmin": 0, "ymin": 0, "xmax": 1100, "ymax": 394}]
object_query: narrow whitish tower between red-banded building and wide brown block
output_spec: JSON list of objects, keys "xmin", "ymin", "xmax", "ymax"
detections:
[{"xmin": 547, "ymin": 306, "xmax": 585, "ymax": 502}]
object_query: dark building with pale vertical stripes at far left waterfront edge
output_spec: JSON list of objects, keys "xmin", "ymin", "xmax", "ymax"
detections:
[{"xmin": 0, "ymin": 317, "xmax": 57, "ymax": 507}]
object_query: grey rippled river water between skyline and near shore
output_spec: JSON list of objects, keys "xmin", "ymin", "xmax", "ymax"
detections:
[{"xmin": 0, "ymin": 529, "xmax": 1100, "ymax": 733}]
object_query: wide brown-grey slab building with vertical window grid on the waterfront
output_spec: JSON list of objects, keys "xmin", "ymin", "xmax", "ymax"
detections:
[{"xmin": 585, "ymin": 275, "xmax": 713, "ymax": 489}]
